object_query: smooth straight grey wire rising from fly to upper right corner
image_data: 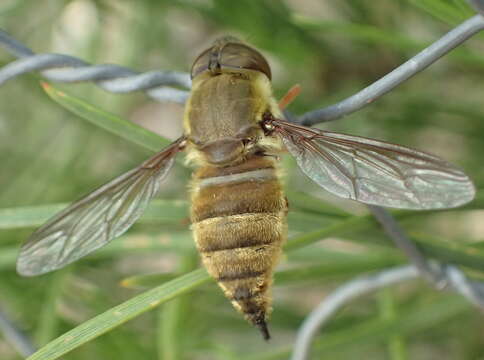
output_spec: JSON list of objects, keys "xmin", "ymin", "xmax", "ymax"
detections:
[{"xmin": 298, "ymin": 13, "xmax": 484, "ymax": 126}]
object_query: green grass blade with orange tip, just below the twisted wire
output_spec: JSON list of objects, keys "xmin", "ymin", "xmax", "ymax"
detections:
[{"xmin": 42, "ymin": 82, "xmax": 171, "ymax": 151}]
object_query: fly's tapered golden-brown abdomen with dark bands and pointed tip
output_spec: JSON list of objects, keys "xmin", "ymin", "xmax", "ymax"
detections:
[{"xmin": 191, "ymin": 156, "xmax": 287, "ymax": 338}]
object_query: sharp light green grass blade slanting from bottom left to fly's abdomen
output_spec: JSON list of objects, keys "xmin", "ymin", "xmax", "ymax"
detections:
[{"xmin": 27, "ymin": 269, "xmax": 210, "ymax": 360}]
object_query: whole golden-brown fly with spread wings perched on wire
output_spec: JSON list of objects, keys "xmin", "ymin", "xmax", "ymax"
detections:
[{"xmin": 17, "ymin": 38, "xmax": 475, "ymax": 339}]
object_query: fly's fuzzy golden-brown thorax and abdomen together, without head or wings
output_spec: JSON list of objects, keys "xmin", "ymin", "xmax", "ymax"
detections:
[{"xmin": 184, "ymin": 63, "xmax": 287, "ymax": 337}]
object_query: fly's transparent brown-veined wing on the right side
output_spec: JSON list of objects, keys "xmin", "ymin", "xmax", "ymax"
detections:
[{"xmin": 274, "ymin": 120, "xmax": 475, "ymax": 209}]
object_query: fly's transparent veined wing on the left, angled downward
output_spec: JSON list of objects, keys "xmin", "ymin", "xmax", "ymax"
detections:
[{"xmin": 17, "ymin": 138, "xmax": 183, "ymax": 276}]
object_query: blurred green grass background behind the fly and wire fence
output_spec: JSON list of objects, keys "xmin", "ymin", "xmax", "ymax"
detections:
[{"xmin": 0, "ymin": 0, "xmax": 484, "ymax": 360}]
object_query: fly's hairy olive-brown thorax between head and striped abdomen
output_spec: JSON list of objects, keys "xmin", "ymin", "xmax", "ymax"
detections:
[{"xmin": 184, "ymin": 71, "xmax": 280, "ymax": 166}]
